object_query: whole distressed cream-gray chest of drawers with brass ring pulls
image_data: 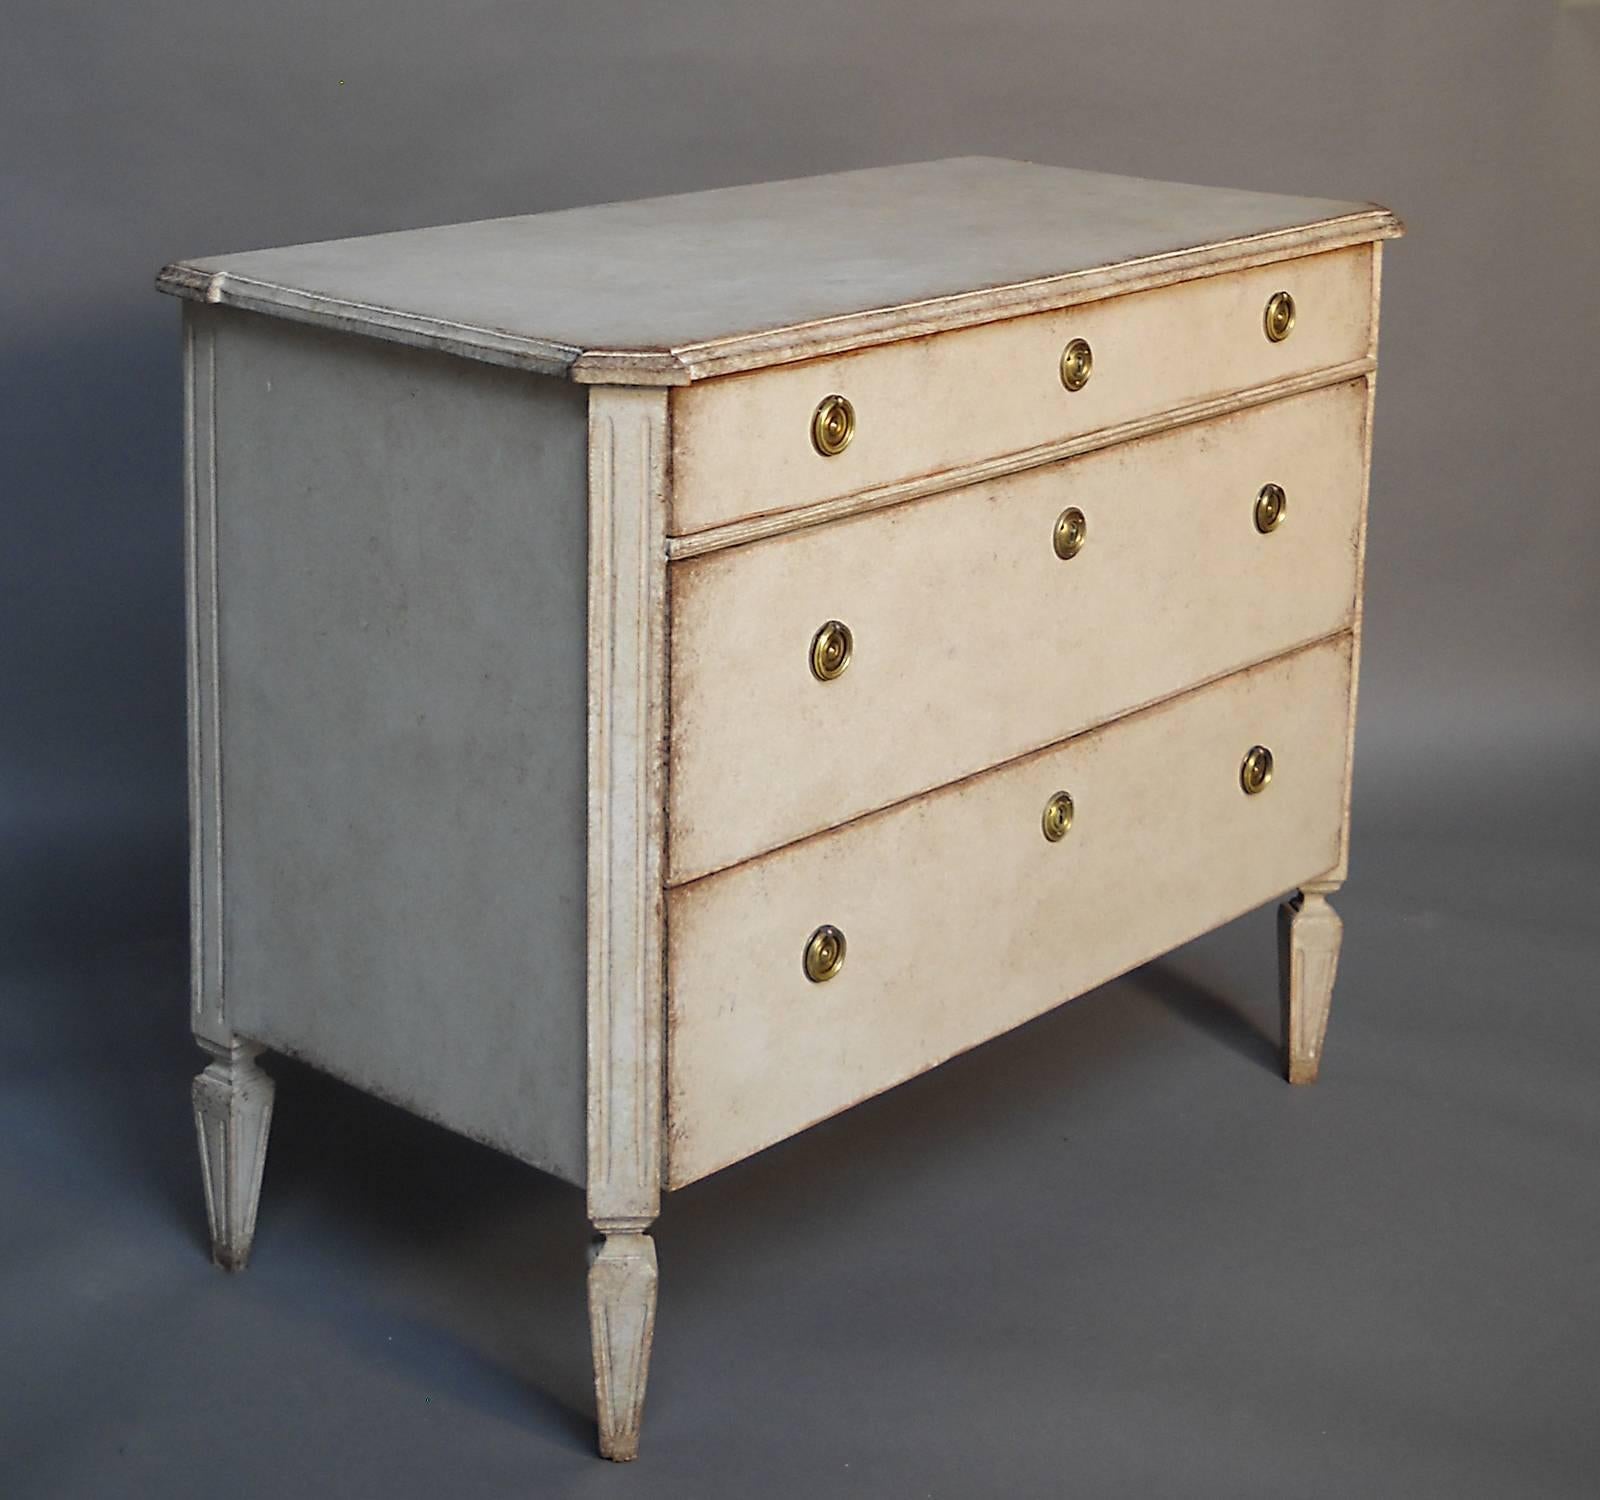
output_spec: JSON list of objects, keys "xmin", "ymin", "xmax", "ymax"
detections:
[{"xmin": 160, "ymin": 158, "xmax": 1400, "ymax": 1458}]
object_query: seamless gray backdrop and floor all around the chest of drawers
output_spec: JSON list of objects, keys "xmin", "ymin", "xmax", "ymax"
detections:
[{"xmin": 0, "ymin": 0, "xmax": 1600, "ymax": 1497}]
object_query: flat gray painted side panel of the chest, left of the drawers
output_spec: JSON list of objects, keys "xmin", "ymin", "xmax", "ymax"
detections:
[{"xmin": 210, "ymin": 312, "xmax": 587, "ymax": 1183}]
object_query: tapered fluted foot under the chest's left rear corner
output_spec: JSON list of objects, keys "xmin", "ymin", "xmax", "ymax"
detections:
[{"xmin": 194, "ymin": 1041, "xmax": 272, "ymax": 1271}]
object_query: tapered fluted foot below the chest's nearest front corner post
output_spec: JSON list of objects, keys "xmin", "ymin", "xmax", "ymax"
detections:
[{"xmin": 589, "ymin": 1233, "xmax": 656, "ymax": 1462}]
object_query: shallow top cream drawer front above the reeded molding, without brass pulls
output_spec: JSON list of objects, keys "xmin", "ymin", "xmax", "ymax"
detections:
[{"xmin": 670, "ymin": 246, "xmax": 1373, "ymax": 536}]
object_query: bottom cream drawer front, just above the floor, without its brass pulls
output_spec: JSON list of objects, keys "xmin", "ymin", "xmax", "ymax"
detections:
[{"xmin": 667, "ymin": 635, "xmax": 1350, "ymax": 1185}]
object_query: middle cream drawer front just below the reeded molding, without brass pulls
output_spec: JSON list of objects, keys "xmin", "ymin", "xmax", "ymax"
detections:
[{"xmin": 667, "ymin": 381, "xmax": 1366, "ymax": 883}]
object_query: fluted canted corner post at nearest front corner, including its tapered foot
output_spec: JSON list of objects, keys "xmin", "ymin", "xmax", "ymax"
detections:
[{"xmin": 587, "ymin": 389, "xmax": 667, "ymax": 1460}]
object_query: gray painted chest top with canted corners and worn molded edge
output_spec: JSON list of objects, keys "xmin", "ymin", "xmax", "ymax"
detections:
[{"xmin": 158, "ymin": 157, "xmax": 1398, "ymax": 384}]
